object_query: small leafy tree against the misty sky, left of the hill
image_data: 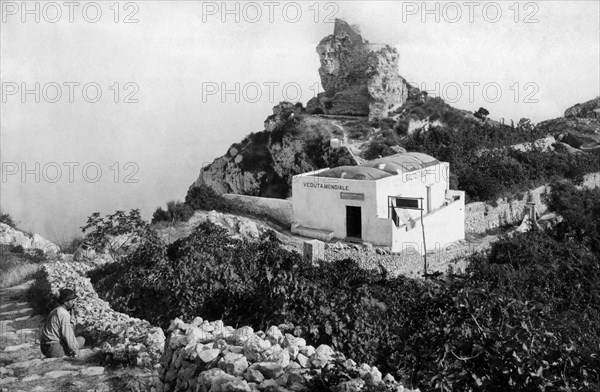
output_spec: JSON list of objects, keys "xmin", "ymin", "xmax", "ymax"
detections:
[{"xmin": 81, "ymin": 209, "xmax": 151, "ymax": 261}]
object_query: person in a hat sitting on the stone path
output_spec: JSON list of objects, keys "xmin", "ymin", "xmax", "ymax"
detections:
[{"xmin": 40, "ymin": 289, "xmax": 85, "ymax": 358}]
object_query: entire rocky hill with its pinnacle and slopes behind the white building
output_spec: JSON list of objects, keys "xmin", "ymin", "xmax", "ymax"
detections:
[{"xmin": 190, "ymin": 20, "xmax": 600, "ymax": 199}]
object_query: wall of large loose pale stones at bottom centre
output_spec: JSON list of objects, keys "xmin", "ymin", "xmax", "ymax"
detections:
[{"xmin": 159, "ymin": 317, "xmax": 418, "ymax": 392}]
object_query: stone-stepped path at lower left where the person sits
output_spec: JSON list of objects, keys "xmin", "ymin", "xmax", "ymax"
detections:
[{"xmin": 0, "ymin": 281, "xmax": 154, "ymax": 392}]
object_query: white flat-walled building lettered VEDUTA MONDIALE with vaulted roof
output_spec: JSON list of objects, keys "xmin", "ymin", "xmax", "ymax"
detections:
[{"xmin": 291, "ymin": 152, "xmax": 465, "ymax": 254}]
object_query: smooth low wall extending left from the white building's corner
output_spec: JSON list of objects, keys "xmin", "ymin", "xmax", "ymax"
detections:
[{"xmin": 223, "ymin": 193, "xmax": 293, "ymax": 229}]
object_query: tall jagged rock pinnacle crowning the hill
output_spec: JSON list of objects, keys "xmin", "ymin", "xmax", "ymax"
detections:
[{"xmin": 307, "ymin": 19, "xmax": 409, "ymax": 119}]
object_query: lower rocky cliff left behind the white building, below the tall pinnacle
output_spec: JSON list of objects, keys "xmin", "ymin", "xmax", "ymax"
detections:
[{"xmin": 192, "ymin": 102, "xmax": 366, "ymax": 198}]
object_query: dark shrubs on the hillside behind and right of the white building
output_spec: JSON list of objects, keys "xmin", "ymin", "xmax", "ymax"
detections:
[{"xmin": 384, "ymin": 98, "xmax": 600, "ymax": 201}]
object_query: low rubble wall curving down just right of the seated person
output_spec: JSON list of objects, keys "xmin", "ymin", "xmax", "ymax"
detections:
[{"xmin": 43, "ymin": 261, "xmax": 165, "ymax": 367}]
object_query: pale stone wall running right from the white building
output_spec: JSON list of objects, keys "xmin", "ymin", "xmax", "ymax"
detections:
[{"xmin": 465, "ymin": 173, "xmax": 600, "ymax": 234}]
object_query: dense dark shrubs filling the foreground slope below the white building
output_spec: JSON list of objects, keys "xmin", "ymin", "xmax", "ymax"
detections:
[{"xmin": 92, "ymin": 182, "xmax": 600, "ymax": 391}]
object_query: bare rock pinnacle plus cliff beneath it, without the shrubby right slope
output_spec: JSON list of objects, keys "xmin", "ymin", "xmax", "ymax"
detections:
[{"xmin": 192, "ymin": 19, "xmax": 418, "ymax": 198}]
